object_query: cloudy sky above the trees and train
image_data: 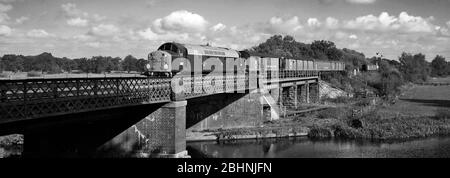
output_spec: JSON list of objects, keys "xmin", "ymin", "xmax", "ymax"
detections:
[{"xmin": 0, "ymin": 0, "xmax": 450, "ymax": 61}]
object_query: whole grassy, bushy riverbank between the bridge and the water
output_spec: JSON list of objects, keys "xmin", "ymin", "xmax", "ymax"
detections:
[{"xmin": 187, "ymin": 82, "xmax": 450, "ymax": 141}]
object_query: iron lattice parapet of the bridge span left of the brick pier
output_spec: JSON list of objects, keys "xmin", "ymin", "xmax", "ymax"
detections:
[{"xmin": 0, "ymin": 77, "xmax": 171, "ymax": 122}]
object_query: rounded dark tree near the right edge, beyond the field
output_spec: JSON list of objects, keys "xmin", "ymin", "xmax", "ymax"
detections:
[{"xmin": 399, "ymin": 52, "xmax": 430, "ymax": 82}]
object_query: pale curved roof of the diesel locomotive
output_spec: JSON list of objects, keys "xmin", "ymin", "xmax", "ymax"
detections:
[{"xmin": 161, "ymin": 43, "xmax": 239, "ymax": 58}]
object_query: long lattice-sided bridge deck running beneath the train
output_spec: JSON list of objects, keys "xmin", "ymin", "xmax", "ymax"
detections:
[{"xmin": 0, "ymin": 71, "xmax": 332, "ymax": 123}]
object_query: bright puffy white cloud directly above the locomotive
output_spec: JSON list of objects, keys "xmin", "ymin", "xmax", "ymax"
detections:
[{"xmin": 152, "ymin": 10, "xmax": 208, "ymax": 33}]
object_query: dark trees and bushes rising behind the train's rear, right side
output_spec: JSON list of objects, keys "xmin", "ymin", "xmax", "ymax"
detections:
[{"xmin": 247, "ymin": 35, "xmax": 450, "ymax": 100}]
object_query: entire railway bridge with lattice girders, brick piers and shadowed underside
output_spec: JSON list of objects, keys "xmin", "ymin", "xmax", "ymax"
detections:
[{"xmin": 0, "ymin": 71, "xmax": 342, "ymax": 157}]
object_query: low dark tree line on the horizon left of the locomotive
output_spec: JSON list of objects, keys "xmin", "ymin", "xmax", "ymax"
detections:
[{"xmin": 0, "ymin": 52, "xmax": 146, "ymax": 74}]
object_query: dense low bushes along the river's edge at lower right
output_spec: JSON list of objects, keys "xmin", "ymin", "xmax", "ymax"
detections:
[{"xmin": 308, "ymin": 105, "xmax": 450, "ymax": 140}]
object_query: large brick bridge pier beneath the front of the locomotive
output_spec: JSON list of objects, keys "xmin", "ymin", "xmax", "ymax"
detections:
[{"xmin": 149, "ymin": 101, "xmax": 189, "ymax": 158}]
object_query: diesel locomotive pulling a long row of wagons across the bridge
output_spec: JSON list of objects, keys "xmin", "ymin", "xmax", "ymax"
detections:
[{"xmin": 143, "ymin": 42, "xmax": 345, "ymax": 77}]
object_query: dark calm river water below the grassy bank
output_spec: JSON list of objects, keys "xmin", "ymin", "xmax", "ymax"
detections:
[{"xmin": 187, "ymin": 137, "xmax": 450, "ymax": 158}]
